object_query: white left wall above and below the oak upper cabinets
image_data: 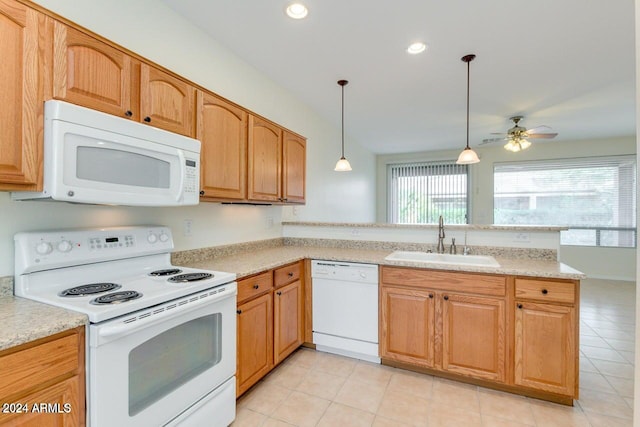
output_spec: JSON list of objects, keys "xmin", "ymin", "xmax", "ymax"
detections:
[{"xmin": 0, "ymin": 0, "xmax": 375, "ymax": 277}]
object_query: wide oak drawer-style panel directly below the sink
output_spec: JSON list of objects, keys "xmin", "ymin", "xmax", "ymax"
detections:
[{"xmin": 382, "ymin": 267, "xmax": 506, "ymax": 296}]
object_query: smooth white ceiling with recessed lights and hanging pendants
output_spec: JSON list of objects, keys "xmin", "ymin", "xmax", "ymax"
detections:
[{"xmin": 163, "ymin": 0, "xmax": 636, "ymax": 156}]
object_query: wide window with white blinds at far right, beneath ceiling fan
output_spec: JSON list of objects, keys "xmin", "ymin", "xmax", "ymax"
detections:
[{"xmin": 493, "ymin": 156, "xmax": 637, "ymax": 247}]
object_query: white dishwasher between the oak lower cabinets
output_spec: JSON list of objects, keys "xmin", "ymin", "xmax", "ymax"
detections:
[{"xmin": 311, "ymin": 260, "xmax": 380, "ymax": 363}]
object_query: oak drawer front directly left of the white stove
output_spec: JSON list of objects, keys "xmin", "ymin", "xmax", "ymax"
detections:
[{"xmin": 0, "ymin": 334, "xmax": 80, "ymax": 396}]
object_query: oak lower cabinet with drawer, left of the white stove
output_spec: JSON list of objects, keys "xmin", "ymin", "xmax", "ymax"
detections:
[{"xmin": 0, "ymin": 327, "xmax": 86, "ymax": 427}]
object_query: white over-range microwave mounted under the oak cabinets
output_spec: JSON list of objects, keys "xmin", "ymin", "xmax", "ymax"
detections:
[{"xmin": 12, "ymin": 100, "xmax": 200, "ymax": 206}]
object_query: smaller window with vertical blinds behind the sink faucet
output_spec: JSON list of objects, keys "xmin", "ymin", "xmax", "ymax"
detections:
[{"xmin": 387, "ymin": 163, "xmax": 469, "ymax": 224}]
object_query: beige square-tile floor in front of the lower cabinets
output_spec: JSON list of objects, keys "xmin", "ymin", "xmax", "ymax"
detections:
[{"xmin": 232, "ymin": 280, "xmax": 635, "ymax": 427}]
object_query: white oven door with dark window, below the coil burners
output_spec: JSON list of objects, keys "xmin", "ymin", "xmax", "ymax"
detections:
[{"xmin": 87, "ymin": 283, "xmax": 236, "ymax": 427}]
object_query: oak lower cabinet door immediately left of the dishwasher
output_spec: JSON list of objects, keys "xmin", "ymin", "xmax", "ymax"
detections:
[{"xmin": 273, "ymin": 280, "xmax": 304, "ymax": 365}]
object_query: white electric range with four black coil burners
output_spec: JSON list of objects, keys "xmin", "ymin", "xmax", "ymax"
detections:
[{"xmin": 15, "ymin": 226, "xmax": 237, "ymax": 427}]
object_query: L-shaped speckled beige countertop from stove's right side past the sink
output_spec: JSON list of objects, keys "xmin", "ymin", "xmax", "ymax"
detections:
[{"xmin": 179, "ymin": 246, "xmax": 586, "ymax": 280}]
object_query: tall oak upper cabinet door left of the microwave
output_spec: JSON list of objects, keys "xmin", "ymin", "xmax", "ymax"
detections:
[{"xmin": 0, "ymin": 0, "xmax": 45, "ymax": 191}]
